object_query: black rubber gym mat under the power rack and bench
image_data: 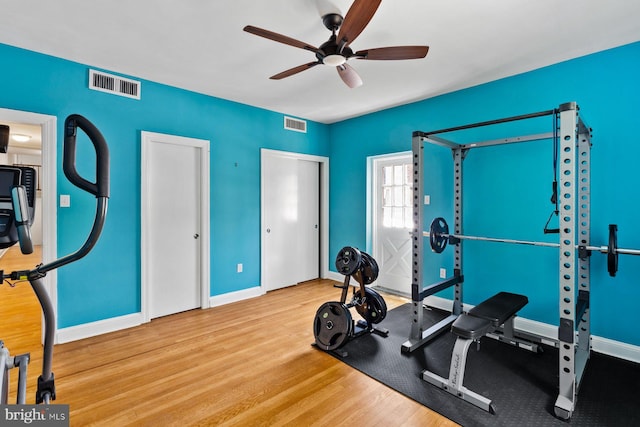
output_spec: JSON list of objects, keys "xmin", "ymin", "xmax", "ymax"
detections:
[{"xmin": 330, "ymin": 304, "xmax": 640, "ymax": 427}]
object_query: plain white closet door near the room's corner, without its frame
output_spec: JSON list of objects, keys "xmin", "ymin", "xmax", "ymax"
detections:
[{"xmin": 262, "ymin": 151, "xmax": 320, "ymax": 291}]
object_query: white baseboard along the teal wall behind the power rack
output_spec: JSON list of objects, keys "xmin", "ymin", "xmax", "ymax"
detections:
[{"xmin": 423, "ymin": 296, "xmax": 640, "ymax": 363}]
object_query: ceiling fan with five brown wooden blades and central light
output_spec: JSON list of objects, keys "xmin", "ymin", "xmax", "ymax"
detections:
[{"xmin": 244, "ymin": 0, "xmax": 429, "ymax": 88}]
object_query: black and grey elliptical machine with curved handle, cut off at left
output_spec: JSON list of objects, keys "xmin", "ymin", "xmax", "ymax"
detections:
[{"xmin": 0, "ymin": 114, "xmax": 109, "ymax": 405}]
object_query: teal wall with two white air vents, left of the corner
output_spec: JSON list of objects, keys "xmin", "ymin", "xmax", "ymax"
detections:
[{"xmin": 0, "ymin": 44, "xmax": 329, "ymax": 328}]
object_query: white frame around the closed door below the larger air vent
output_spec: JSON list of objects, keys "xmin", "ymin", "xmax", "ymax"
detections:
[{"xmin": 140, "ymin": 131, "xmax": 211, "ymax": 322}]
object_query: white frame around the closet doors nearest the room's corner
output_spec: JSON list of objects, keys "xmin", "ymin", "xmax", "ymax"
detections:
[{"xmin": 260, "ymin": 148, "xmax": 329, "ymax": 294}]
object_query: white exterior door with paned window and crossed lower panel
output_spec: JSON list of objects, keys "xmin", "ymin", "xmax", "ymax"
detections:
[{"xmin": 373, "ymin": 155, "xmax": 413, "ymax": 295}]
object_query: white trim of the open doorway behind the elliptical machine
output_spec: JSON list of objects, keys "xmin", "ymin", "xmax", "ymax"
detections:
[{"xmin": 0, "ymin": 108, "xmax": 58, "ymax": 342}]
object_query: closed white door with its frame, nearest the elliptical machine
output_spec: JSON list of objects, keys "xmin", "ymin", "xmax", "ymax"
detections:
[{"xmin": 142, "ymin": 132, "xmax": 208, "ymax": 319}]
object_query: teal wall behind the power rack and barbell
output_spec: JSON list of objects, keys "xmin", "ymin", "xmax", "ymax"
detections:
[{"xmin": 330, "ymin": 43, "xmax": 640, "ymax": 345}]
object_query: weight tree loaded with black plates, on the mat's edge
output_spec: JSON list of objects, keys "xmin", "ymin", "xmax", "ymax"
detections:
[{"xmin": 313, "ymin": 246, "xmax": 389, "ymax": 357}]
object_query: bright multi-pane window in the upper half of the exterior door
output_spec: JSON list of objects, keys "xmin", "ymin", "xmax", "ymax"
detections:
[{"xmin": 382, "ymin": 163, "xmax": 413, "ymax": 229}]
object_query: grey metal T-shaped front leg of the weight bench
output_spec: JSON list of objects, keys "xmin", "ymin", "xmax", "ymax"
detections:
[{"xmin": 422, "ymin": 338, "xmax": 495, "ymax": 414}]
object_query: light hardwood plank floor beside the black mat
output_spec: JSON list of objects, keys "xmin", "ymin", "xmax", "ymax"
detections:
[{"xmin": 2, "ymin": 258, "xmax": 456, "ymax": 426}]
